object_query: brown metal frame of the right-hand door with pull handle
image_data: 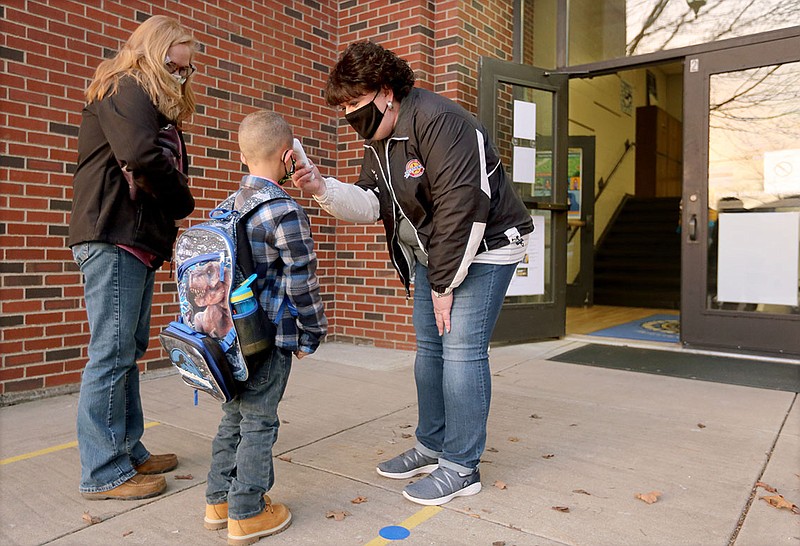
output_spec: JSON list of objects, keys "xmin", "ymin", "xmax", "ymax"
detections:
[{"xmin": 681, "ymin": 33, "xmax": 800, "ymax": 355}]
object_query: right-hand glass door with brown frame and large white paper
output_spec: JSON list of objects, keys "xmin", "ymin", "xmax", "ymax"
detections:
[{"xmin": 681, "ymin": 33, "xmax": 800, "ymax": 355}]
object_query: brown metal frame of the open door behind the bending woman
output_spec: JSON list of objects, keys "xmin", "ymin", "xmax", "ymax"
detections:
[{"xmin": 478, "ymin": 57, "xmax": 569, "ymax": 343}]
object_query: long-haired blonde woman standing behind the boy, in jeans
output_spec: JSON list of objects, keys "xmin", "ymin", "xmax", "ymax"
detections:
[{"xmin": 68, "ymin": 16, "xmax": 196, "ymax": 500}]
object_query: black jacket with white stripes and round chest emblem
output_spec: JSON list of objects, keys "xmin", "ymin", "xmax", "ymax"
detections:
[{"xmin": 357, "ymin": 88, "xmax": 533, "ymax": 292}]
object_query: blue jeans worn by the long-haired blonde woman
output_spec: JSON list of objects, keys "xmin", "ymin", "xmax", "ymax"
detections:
[{"xmin": 72, "ymin": 242, "xmax": 155, "ymax": 493}]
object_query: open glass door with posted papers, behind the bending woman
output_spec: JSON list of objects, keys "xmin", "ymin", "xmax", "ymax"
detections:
[{"xmin": 479, "ymin": 58, "xmax": 569, "ymax": 342}]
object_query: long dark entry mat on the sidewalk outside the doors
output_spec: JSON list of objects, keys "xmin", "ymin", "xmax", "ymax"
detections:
[{"xmin": 549, "ymin": 343, "xmax": 800, "ymax": 392}]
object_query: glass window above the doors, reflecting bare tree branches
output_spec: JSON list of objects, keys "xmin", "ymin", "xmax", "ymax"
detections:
[{"xmin": 568, "ymin": 0, "xmax": 800, "ymax": 65}]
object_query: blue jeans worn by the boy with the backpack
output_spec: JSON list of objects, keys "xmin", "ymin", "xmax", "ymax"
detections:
[{"xmin": 206, "ymin": 348, "xmax": 292, "ymax": 519}]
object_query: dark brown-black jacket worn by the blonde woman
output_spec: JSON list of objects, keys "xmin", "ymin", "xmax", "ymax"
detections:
[{"xmin": 67, "ymin": 77, "xmax": 194, "ymax": 260}]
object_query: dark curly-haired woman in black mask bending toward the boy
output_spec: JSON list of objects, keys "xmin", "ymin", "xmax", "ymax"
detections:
[{"xmin": 294, "ymin": 42, "xmax": 533, "ymax": 505}]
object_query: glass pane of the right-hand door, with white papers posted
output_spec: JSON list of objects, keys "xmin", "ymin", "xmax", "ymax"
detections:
[{"xmin": 707, "ymin": 62, "xmax": 800, "ymax": 315}]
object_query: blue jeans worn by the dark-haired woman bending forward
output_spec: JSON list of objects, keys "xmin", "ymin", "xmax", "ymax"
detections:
[{"xmin": 413, "ymin": 263, "xmax": 516, "ymax": 473}]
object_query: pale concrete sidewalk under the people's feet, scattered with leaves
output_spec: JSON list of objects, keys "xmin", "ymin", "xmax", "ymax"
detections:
[{"xmin": 0, "ymin": 338, "xmax": 800, "ymax": 546}]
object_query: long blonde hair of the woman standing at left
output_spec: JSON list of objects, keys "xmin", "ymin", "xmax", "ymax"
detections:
[{"xmin": 85, "ymin": 15, "xmax": 197, "ymax": 124}]
